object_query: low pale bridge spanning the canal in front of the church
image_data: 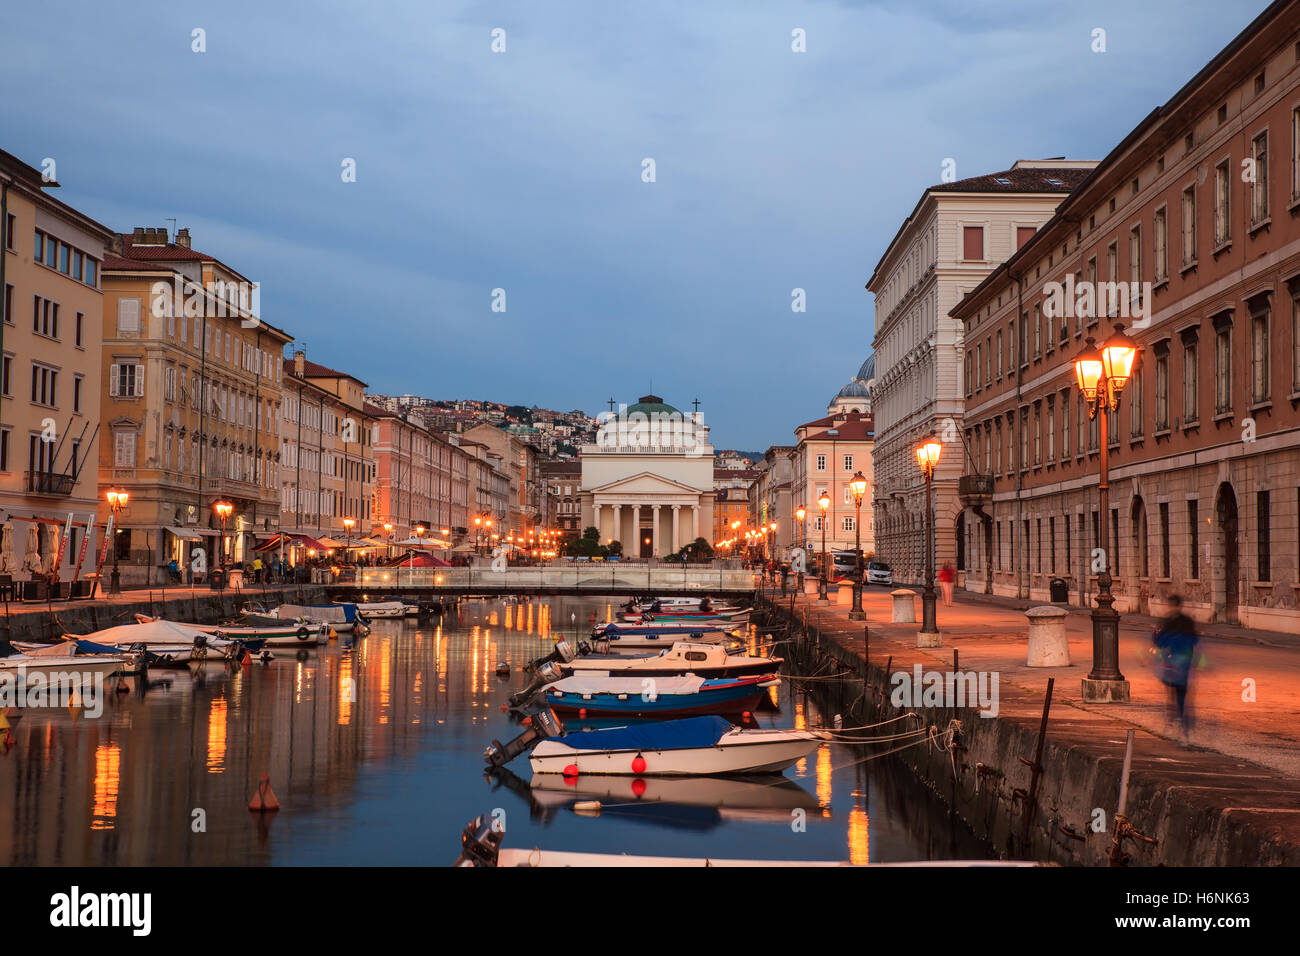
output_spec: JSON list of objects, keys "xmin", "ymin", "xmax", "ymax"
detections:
[{"xmin": 330, "ymin": 563, "xmax": 759, "ymax": 597}]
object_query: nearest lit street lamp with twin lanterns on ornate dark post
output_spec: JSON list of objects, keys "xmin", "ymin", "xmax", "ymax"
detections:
[{"xmin": 1074, "ymin": 324, "xmax": 1140, "ymax": 701}]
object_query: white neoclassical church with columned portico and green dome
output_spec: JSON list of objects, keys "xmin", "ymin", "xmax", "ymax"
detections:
[{"xmin": 581, "ymin": 395, "xmax": 714, "ymax": 558}]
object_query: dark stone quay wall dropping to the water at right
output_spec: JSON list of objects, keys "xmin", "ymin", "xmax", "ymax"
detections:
[{"xmin": 755, "ymin": 593, "xmax": 1300, "ymax": 866}]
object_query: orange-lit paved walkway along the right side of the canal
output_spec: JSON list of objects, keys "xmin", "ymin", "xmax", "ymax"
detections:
[{"xmin": 768, "ymin": 587, "xmax": 1300, "ymax": 780}]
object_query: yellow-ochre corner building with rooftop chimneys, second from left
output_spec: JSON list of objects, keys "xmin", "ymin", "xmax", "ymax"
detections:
[{"xmin": 99, "ymin": 228, "xmax": 290, "ymax": 584}]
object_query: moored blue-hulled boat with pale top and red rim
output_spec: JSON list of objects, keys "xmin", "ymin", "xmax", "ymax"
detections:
[{"xmin": 535, "ymin": 674, "xmax": 780, "ymax": 717}]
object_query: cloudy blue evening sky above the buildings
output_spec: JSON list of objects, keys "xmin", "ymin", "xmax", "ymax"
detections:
[{"xmin": 0, "ymin": 0, "xmax": 1265, "ymax": 450}]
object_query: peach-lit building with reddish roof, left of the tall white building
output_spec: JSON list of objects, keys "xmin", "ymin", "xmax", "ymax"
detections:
[{"xmin": 777, "ymin": 411, "xmax": 876, "ymax": 554}]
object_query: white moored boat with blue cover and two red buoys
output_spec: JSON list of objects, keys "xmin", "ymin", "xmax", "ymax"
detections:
[{"xmin": 528, "ymin": 717, "xmax": 831, "ymax": 777}]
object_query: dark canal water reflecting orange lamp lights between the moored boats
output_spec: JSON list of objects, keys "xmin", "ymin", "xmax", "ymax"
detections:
[{"xmin": 0, "ymin": 598, "xmax": 991, "ymax": 866}]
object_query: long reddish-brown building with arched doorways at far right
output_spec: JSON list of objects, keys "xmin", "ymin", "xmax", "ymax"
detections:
[{"xmin": 941, "ymin": 3, "xmax": 1300, "ymax": 632}]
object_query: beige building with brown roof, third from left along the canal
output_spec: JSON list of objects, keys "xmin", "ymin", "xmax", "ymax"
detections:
[{"xmin": 280, "ymin": 350, "xmax": 376, "ymax": 557}]
